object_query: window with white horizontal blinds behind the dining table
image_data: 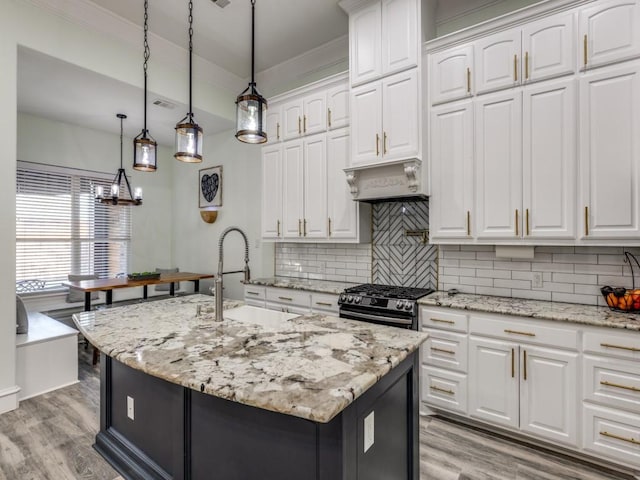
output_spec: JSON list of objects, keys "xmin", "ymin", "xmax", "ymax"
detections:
[{"xmin": 16, "ymin": 162, "xmax": 131, "ymax": 291}]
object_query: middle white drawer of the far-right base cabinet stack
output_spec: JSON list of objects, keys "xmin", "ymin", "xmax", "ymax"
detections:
[{"xmin": 584, "ymin": 355, "xmax": 640, "ymax": 414}]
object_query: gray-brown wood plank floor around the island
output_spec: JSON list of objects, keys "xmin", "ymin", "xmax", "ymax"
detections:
[{"xmin": 0, "ymin": 348, "xmax": 624, "ymax": 480}]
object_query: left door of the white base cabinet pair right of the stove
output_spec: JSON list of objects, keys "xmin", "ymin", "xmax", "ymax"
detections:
[{"xmin": 469, "ymin": 336, "xmax": 520, "ymax": 428}]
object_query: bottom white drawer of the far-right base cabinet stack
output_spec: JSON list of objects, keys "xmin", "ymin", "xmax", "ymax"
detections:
[{"xmin": 584, "ymin": 405, "xmax": 640, "ymax": 467}]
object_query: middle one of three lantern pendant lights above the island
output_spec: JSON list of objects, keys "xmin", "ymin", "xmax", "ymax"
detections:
[{"xmin": 173, "ymin": 0, "xmax": 202, "ymax": 163}]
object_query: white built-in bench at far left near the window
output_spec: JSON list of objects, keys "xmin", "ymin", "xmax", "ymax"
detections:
[{"xmin": 16, "ymin": 312, "xmax": 78, "ymax": 400}]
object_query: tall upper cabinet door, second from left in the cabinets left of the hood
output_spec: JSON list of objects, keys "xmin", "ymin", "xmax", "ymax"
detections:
[{"xmin": 282, "ymin": 140, "xmax": 304, "ymax": 238}]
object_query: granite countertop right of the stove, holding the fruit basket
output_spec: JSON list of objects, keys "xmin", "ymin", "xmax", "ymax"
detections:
[{"xmin": 418, "ymin": 292, "xmax": 640, "ymax": 331}]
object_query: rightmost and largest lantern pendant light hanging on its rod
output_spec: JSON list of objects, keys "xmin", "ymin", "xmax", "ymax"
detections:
[{"xmin": 236, "ymin": 0, "xmax": 267, "ymax": 143}]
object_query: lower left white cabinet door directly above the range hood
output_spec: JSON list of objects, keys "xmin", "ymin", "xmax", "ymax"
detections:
[{"xmin": 351, "ymin": 82, "xmax": 382, "ymax": 166}]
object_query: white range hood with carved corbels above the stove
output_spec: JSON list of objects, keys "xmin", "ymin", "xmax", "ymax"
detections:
[{"xmin": 344, "ymin": 159, "xmax": 427, "ymax": 203}]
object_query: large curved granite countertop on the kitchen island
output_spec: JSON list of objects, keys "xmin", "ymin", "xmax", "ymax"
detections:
[{"xmin": 74, "ymin": 294, "xmax": 427, "ymax": 423}]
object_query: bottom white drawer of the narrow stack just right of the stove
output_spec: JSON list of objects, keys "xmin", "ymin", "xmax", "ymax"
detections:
[{"xmin": 420, "ymin": 365, "xmax": 467, "ymax": 415}]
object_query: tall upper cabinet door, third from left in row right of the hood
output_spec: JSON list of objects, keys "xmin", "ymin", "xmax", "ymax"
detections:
[{"xmin": 522, "ymin": 77, "xmax": 577, "ymax": 238}]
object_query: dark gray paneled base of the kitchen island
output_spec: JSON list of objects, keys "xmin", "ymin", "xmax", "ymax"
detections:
[{"xmin": 94, "ymin": 353, "xmax": 420, "ymax": 480}]
